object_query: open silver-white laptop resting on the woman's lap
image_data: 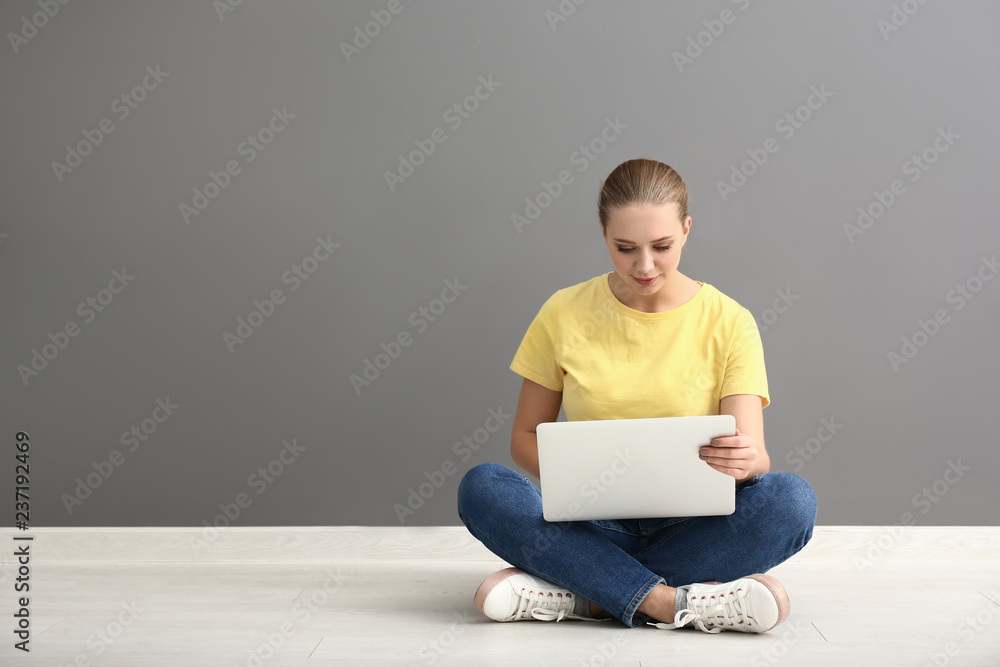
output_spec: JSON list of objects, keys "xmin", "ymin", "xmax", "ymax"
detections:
[{"xmin": 535, "ymin": 415, "xmax": 736, "ymax": 521}]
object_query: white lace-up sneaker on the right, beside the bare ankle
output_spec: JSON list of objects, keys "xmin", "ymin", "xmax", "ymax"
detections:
[{"xmin": 649, "ymin": 574, "xmax": 790, "ymax": 634}]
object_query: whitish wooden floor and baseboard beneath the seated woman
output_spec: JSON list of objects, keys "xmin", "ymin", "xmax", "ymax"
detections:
[{"xmin": 0, "ymin": 526, "xmax": 1000, "ymax": 667}]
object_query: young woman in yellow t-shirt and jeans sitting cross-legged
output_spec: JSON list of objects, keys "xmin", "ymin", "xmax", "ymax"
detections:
[{"xmin": 458, "ymin": 159, "xmax": 816, "ymax": 633}]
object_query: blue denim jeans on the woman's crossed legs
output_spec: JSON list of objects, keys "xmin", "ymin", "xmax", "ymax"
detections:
[{"xmin": 458, "ymin": 463, "xmax": 816, "ymax": 627}]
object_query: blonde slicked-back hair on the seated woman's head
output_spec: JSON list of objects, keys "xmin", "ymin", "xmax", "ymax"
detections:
[{"xmin": 597, "ymin": 158, "xmax": 688, "ymax": 234}]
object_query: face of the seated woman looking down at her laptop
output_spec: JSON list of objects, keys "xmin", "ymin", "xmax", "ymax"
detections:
[{"xmin": 604, "ymin": 202, "xmax": 691, "ymax": 296}]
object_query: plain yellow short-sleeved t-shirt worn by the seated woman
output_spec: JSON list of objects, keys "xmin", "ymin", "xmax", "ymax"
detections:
[{"xmin": 510, "ymin": 274, "xmax": 770, "ymax": 421}]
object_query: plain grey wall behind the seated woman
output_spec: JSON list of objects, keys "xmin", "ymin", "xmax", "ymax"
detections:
[{"xmin": 0, "ymin": 0, "xmax": 1000, "ymax": 526}]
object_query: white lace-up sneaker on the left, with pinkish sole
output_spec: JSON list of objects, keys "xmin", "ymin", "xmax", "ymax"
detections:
[{"xmin": 474, "ymin": 567, "xmax": 609, "ymax": 622}]
